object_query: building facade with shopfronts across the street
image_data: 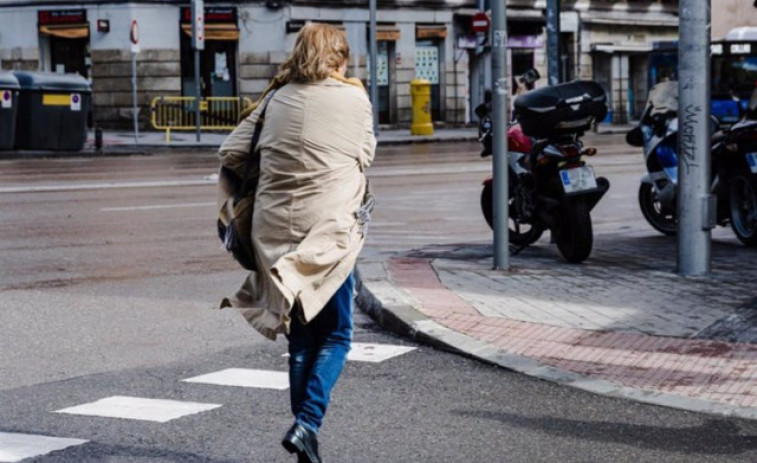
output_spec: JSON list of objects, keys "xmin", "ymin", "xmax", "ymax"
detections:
[{"xmin": 0, "ymin": 0, "xmax": 678, "ymax": 128}]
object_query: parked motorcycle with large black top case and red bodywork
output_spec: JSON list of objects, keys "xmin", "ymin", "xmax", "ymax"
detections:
[{"xmin": 476, "ymin": 74, "xmax": 610, "ymax": 263}]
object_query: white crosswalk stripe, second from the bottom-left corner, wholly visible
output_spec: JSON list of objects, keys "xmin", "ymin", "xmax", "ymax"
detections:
[{"xmin": 55, "ymin": 396, "xmax": 221, "ymax": 423}]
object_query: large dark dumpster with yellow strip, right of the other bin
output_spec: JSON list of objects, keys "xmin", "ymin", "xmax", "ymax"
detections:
[{"xmin": 13, "ymin": 71, "xmax": 92, "ymax": 151}]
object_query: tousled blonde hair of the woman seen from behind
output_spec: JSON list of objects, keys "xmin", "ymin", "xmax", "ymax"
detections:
[{"xmin": 275, "ymin": 23, "xmax": 350, "ymax": 83}]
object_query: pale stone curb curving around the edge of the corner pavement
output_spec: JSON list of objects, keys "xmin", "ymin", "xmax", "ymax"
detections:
[{"xmin": 355, "ymin": 269, "xmax": 757, "ymax": 420}]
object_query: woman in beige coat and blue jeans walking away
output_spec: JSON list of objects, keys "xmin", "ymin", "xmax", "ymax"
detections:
[{"xmin": 219, "ymin": 24, "xmax": 376, "ymax": 463}]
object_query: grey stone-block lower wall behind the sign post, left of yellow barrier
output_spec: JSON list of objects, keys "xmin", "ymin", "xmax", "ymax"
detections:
[{"xmin": 92, "ymin": 50, "xmax": 181, "ymax": 129}]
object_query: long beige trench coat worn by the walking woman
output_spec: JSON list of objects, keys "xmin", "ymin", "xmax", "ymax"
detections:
[{"xmin": 219, "ymin": 78, "xmax": 376, "ymax": 339}]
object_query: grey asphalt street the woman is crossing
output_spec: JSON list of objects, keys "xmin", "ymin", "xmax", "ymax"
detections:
[{"xmin": 0, "ymin": 136, "xmax": 757, "ymax": 463}]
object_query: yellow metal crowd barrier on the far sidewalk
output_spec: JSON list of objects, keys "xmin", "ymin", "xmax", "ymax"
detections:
[{"xmin": 150, "ymin": 96, "xmax": 252, "ymax": 137}]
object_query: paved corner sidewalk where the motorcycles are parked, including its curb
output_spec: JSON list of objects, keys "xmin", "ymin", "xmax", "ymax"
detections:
[{"xmin": 358, "ymin": 230, "xmax": 757, "ymax": 419}]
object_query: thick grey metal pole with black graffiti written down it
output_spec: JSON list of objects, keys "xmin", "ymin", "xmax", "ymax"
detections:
[{"xmin": 678, "ymin": 0, "xmax": 716, "ymax": 276}]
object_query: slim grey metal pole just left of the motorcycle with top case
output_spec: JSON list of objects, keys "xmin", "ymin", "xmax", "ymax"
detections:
[{"xmin": 491, "ymin": 0, "xmax": 510, "ymax": 270}]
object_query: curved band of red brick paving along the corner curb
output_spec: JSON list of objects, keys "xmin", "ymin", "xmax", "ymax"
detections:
[{"xmin": 388, "ymin": 258, "xmax": 757, "ymax": 407}]
